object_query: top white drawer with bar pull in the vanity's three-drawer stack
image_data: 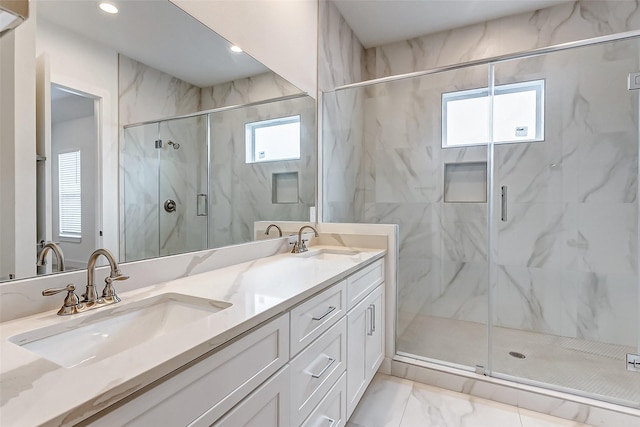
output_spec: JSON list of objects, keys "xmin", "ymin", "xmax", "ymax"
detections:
[{"xmin": 290, "ymin": 280, "xmax": 347, "ymax": 357}]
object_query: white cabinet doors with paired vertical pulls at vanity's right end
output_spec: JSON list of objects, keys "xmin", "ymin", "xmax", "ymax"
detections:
[{"xmin": 347, "ymin": 286, "xmax": 384, "ymax": 418}]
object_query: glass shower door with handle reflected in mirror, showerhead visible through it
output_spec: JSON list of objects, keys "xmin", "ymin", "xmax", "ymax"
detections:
[{"xmin": 158, "ymin": 115, "xmax": 208, "ymax": 255}]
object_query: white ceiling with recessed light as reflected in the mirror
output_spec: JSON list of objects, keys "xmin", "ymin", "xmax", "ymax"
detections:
[{"xmin": 37, "ymin": 0, "xmax": 268, "ymax": 87}]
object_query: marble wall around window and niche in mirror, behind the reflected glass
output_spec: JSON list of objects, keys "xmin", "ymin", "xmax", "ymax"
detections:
[{"xmin": 209, "ymin": 97, "xmax": 316, "ymax": 251}]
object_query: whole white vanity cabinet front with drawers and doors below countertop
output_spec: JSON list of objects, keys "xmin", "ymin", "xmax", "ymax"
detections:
[{"xmin": 82, "ymin": 259, "xmax": 384, "ymax": 427}]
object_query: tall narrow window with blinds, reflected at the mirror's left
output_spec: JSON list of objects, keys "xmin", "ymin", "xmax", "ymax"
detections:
[{"xmin": 58, "ymin": 150, "xmax": 82, "ymax": 238}]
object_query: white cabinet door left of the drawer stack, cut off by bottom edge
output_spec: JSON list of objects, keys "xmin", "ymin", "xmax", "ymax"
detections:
[{"xmin": 210, "ymin": 366, "xmax": 290, "ymax": 427}]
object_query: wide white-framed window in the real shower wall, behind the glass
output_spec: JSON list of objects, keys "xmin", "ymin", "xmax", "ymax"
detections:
[{"xmin": 442, "ymin": 80, "xmax": 544, "ymax": 148}]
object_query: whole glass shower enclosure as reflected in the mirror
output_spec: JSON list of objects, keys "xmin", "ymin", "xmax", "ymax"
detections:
[{"xmin": 120, "ymin": 96, "xmax": 315, "ymax": 261}]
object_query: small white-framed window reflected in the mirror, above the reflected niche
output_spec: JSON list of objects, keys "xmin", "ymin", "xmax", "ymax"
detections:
[{"xmin": 245, "ymin": 115, "xmax": 300, "ymax": 163}]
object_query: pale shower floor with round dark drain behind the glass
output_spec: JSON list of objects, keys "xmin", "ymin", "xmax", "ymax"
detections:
[{"xmin": 397, "ymin": 314, "xmax": 640, "ymax": 407}]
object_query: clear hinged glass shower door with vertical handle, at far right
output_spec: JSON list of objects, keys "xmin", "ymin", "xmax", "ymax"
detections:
[{"xmin": 490, "ymin": 39, "xmax": 640, "ymax": 407}]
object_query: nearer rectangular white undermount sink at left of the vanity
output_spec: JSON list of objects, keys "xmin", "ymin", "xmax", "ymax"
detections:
[{"xmin": 9, "ymin": 293, "xmax": 232, "ymax": 368}]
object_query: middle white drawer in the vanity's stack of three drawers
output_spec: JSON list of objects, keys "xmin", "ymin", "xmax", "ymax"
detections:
[{"xmin": 290, "ymin": 317, "xmax": 347, "ymax": 426}]
